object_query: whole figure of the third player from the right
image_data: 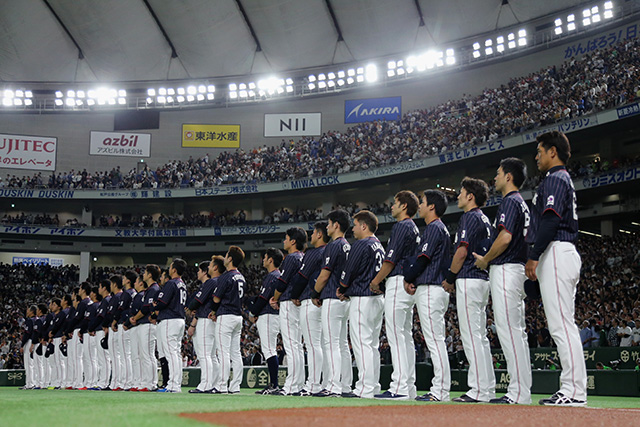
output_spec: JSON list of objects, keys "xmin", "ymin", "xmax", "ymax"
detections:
[{"xmin": 442, "ymin": 177, "xmax": 496, "ymax": 403}]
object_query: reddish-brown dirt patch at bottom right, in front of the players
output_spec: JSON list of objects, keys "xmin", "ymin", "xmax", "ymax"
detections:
[{"xmin": 180, "ymin": 404, "xmax": 640, "ymax": 427}]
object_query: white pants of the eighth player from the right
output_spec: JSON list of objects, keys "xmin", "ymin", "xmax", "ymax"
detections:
[{"xmin": 298, "ymin": 299, "xmax": 323, "ymax": 393}]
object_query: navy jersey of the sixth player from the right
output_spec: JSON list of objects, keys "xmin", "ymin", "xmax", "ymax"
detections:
[{"xmin": 340, "ymin": 237, "xmax": 384, "ymax": 297}]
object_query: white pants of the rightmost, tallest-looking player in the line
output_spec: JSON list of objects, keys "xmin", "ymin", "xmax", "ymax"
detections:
[{"xmin": 536, "ymin": 241, "xmax": 587, "ymax": 401}]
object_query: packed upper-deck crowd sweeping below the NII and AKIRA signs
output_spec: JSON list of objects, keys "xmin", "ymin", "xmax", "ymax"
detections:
[{"xmin": 0, "ymin": 40, "xmax": 640, "ymax": 189}]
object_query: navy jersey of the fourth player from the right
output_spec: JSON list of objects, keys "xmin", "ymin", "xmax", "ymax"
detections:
[{"xmin": 415, "ymin": 219, "xmax": 451, "ymax": 286}]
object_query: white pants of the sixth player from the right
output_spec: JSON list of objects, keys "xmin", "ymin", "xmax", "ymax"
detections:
[{"xmin": 349, "ymin": 295, "xmax": 384, "ymax": 399}]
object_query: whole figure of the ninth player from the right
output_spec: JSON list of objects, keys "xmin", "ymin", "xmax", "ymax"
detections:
[{"xmin": 270, "ymin": 227, "xmax": 307, "ymax": 396}]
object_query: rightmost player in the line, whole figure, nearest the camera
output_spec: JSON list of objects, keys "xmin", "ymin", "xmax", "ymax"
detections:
[{"xmin": 525, "ymin": 131, "xmax": 587, "ymax": 406}]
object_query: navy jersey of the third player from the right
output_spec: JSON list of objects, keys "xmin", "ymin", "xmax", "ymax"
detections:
[{"xmin": 455, "ymin": 208, "xmax": 493, "ymax": 280}]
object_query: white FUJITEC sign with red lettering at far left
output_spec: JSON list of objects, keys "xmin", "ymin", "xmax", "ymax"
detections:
[{"xmin": 0, "ymin": 134, "xmax": 58, "ymax": 171}]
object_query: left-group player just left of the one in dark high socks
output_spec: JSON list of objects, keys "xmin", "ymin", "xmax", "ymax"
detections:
[{"xmin": 129, "ymin": 264, "xmax": 161, "ymax": 391}]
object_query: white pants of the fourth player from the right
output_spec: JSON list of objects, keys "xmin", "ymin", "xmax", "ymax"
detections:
[{"xmin": 414, "ymin": 285, "xmax": 451, "ymax": 402}]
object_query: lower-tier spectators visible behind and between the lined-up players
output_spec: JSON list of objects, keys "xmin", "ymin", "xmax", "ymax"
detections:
[{"xmin": 0, "ymin": 233, "xmax": 640, "ymax": 369}]
